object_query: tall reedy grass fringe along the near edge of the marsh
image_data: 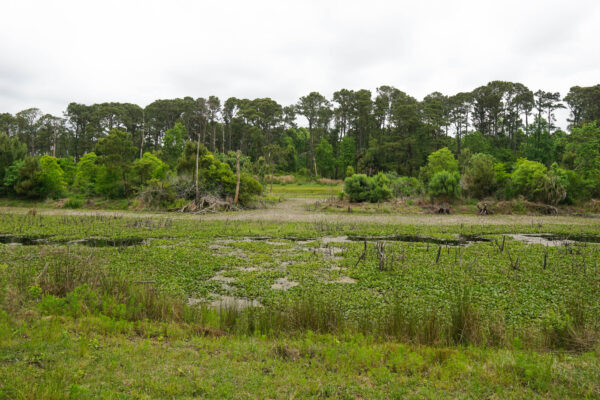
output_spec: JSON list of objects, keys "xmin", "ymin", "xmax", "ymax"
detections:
[{"xmin": 0, "ymin": 250, "xmax": 599, "ymax": 351}]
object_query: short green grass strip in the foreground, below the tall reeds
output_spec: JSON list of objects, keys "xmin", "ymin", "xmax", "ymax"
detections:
[{"xmin": 0, "ymin": 314, "xmax": 600, "ymax": 399}]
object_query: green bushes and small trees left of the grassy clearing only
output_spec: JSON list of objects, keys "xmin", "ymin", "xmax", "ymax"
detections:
[{"xmin": 0, "ymin": 125, "xmax": 262, "ymax": 208}]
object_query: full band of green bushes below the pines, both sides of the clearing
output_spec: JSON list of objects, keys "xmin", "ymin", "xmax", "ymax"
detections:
[{"xmin": 0, "ymin": 116, "xmax": 600, "ymax": 207}]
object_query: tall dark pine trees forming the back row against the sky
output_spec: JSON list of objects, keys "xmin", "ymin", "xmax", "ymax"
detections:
[{"xmin": 0, "ymin": 81, "xmax": 600, "ymax": 206}]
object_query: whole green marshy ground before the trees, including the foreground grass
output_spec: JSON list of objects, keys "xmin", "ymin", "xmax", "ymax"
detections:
[{"xmin": 0, "ymin": 205, "xmax": 600, "ymax": 399}]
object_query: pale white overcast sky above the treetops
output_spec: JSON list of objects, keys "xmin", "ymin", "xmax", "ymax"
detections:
[{"xmin": 0, "ymin": 0, "xmax": 600, "ymax": 125}]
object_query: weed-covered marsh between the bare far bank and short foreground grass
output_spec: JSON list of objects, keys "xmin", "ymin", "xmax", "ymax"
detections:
[{"xmin": 0, "ymin": 214, "xmax": 600, "ymax": 351}]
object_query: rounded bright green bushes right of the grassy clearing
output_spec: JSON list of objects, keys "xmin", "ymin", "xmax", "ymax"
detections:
[{"xmin": 344, "ymin": 141, "xmax": 600, "ymax": 205}]
